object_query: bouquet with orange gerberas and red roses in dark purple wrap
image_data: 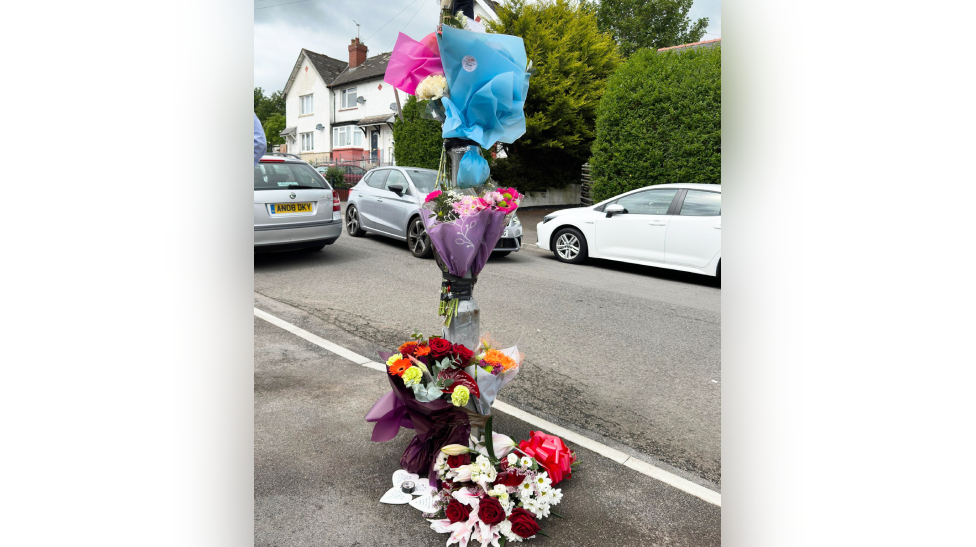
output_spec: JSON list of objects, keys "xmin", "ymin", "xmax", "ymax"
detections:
[{"xmin": 366, "ymin": 332, "xmax": 524, "ymax": 486}]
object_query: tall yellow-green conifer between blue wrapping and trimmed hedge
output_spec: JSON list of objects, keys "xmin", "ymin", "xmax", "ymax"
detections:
[{"xmin": 488, "ymin": 0, "xmax": 621, "ymax": 192}]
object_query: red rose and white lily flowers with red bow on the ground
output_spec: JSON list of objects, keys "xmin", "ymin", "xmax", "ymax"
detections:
[{"xmin": 425, "ymin": 418, "xmax": 576, "ymax": 547}]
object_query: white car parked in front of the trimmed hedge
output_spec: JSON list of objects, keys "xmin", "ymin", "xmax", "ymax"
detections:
[{"xmin": 536, "ymin": 184, "xmax": 722, "ymax": 276}]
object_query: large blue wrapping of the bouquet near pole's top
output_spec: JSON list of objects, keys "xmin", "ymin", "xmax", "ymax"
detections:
[{"xmin": 438, "ymin": 26, "xmax": 529, "ymax": 148}]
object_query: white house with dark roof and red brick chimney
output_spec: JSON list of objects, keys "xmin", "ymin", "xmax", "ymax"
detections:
[{"xmin": 281, "ymin": 38, "xmax": 407, "ymax": 164}]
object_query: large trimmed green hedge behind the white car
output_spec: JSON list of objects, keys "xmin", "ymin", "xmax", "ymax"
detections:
[{"xmin": 590, "ymin": 47, "xmax": 722, "ymax": 201}]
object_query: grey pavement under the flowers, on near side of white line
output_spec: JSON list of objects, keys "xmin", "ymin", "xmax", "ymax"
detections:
[{"xmin": 254, "ymin": 298, "xmax": 721, "ymax": 547}]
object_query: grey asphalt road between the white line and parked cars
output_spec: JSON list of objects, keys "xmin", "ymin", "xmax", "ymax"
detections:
[{"xmin": 254, "ymin": 211, "xmax": 721, "ymax": 491}]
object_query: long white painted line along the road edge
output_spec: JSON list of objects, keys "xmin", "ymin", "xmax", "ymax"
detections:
[{"xmin": 254, "ymin": 308, "xmax": 722, "ymax": 507}]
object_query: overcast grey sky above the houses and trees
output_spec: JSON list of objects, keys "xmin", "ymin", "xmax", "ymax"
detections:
[{"xmin": 254, "ymin": 0, "xmax": 722, "ymax": 95}]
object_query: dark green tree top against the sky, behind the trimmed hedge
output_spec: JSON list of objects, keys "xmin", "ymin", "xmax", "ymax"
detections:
[{"xmin": 597, "ymin": 0, "xmax": 708, "ymax": 57}]
